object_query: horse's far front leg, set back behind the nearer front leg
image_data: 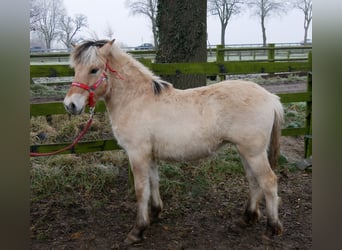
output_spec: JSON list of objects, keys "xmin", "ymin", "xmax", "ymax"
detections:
[{"xmin": 150, "ymin": 163, "xmax": 163, "ymax": 220}]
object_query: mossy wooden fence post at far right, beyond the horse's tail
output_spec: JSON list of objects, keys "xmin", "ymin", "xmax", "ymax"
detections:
[{"xmin": 304, "ymin": 51, "xmax": 312, "ymax": 158}]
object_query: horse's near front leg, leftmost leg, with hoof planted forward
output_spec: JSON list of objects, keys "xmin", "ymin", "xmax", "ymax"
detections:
[{"xmin": 125, "ymin": 154, "xmax": 150, "ymax": 244}]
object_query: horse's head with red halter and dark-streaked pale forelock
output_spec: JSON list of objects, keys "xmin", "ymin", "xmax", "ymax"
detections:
[{"xmin": 63, "ymin": 40, "xmax": 114, "ymax": 114}]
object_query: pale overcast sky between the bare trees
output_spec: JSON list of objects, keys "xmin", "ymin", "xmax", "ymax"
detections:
[{"xmin": 64, "ymin": 0, "xmax": 312, "ymax": 46}]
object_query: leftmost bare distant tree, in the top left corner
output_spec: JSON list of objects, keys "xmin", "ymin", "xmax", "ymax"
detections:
[{"xmin": 34, "ymin": 0, "xmax": 65, "ymax": 49}]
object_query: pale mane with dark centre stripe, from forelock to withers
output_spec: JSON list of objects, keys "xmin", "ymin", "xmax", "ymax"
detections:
[{"xmin": 70, "ymin": 40, "xmax": 172, "ymax": 95}]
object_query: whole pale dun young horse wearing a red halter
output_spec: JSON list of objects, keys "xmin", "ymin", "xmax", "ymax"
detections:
[{"xmin": 64, "ymin": 40, "xmax": 283, "ymax": 244}]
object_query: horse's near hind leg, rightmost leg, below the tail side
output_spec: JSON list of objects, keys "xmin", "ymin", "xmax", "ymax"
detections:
[{"xmin": 240, "ymin": 150, "xmax": 283, "ymax": 235}]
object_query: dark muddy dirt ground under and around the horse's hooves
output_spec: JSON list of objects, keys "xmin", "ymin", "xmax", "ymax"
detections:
[{"xmin": 30, "ymin": 81, "xmax": 312, "ymax": 250}]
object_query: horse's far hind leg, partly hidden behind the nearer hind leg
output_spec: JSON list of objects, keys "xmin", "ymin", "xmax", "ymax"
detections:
[{"xmin": 240, "ymin": 154, "xmax": 263, "ymax": 225}]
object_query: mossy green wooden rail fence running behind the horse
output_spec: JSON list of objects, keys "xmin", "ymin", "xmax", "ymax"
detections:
[{"xmin": 30, "ymin": 45, "xmax": 312, "ymax": 157}]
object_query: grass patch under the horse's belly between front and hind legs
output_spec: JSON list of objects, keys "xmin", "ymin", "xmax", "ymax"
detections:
[{"xmin": 156, "ymin": 144, "xmax": 244, "ymax": 198}]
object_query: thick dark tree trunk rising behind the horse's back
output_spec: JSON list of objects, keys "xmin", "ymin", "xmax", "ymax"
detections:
[{"xmin": 156, "ymin": 0, "xmax": 207, "ymax": 89}]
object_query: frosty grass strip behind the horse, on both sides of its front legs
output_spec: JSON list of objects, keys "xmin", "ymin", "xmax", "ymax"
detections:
[{"xmin": 31, "ymin": 145, "xmax": 244, "ymax": 200}]
